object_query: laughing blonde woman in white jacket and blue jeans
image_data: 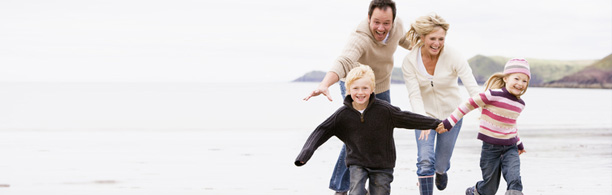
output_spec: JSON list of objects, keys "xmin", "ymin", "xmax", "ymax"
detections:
[{"xmin": 402, "ymin": 13, "xmax": 480, "ymax": 194}]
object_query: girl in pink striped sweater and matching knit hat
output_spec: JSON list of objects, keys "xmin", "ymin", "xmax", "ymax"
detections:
[{"xmin": 443, "ymin": 58, "xmax": 531, "ymax": 195}]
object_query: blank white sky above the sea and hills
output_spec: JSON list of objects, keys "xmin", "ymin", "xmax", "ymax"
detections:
[{"xmin": 0, "ymin": 0, "xmax": 612, "ymax": 82}]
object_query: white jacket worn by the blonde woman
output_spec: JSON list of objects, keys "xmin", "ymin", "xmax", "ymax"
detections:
[{"xmin": 402, "ymin": 46, "xmax": 481, "ymax": 119}]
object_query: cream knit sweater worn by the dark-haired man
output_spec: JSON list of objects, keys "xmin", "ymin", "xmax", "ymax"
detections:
[{"xmin": 330, "ymin": 18, "xmax": 410, "ymax": 94}]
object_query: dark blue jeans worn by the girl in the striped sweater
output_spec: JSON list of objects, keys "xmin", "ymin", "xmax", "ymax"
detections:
[{"xmin": 476, "ymin": 142, "xmax": 523, "ymax": 195}]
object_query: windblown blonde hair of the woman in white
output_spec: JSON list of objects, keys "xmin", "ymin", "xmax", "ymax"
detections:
[{"xmin": 406, "ymin": 13, "xmax": 450, "ymax": 50}]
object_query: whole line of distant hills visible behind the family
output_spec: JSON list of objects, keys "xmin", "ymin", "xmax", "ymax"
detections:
[{"xmin": 294, "ymin": 55, "xmax": 612, "ymax": 87}]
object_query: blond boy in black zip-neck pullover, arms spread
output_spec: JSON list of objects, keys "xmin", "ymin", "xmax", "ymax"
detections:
[{"xmin": 295, "ymin": 65, "xmax": 444, "ymax": 195}]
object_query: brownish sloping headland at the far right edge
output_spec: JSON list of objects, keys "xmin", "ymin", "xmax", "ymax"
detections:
[{"xmin": 543, "ymin": 54, "xmax": 612, "ymax": 89}]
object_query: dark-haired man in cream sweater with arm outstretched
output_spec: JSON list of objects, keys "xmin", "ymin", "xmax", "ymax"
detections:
[{"xmin": 304, "ymin": 0, "xmax": 410, "ymax": 194}]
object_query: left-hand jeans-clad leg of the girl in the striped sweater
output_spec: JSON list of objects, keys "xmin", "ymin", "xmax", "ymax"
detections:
[{"xmin": 476, "ymin": 142, "xmax": 504, "ymax": 195}]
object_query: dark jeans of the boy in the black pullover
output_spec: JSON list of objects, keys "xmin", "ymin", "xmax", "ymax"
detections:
[{"xmin": 349, "ymin": 165, "xmax": 393, "ymax": 195}]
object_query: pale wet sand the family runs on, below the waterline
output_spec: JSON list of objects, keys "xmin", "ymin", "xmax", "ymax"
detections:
[{"xmin": 0, "ymin": 129, "xmax": 612, "ymax": 195}]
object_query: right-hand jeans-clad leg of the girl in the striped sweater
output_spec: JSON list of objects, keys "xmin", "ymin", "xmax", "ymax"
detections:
[{"xmin": 501, "ymin": 145, "xmax": 523, "ymax": 194}]
